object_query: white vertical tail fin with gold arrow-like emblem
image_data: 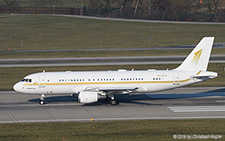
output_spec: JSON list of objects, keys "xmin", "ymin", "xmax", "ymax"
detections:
[{"xmin": 175, "ymin": 37, "xmax": 214, "ymax": 71}]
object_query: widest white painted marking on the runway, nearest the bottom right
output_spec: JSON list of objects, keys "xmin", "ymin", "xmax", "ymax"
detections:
[{"xmin": 168, "ymin": 106, "xmax": 225, "ymax": 112}]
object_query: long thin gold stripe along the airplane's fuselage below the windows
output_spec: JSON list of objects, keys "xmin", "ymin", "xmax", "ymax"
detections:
[{"xmin": 24, "ymin": 79, "xmax": 190, "ymax": 86}]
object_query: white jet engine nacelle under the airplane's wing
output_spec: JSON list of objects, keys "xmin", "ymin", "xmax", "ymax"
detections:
[{"xmin": 78, "ymin": 92, "xmax": 99, "ymax": 103}]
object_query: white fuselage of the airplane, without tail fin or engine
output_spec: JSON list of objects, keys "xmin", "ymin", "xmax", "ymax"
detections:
[{"xmin": 14, "ymin": 70, "xmax": 217, "ymax": 94}]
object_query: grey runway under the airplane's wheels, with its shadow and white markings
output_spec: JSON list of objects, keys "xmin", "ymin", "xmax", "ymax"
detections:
[{"xmin": 0, "ymin": 87, "xmax": 225, "ymax": 123}]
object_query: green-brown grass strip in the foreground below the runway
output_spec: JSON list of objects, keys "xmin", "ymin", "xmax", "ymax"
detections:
[{"xmin": 0, "ymin": 119, "xmax": 225, "ymax": 141}]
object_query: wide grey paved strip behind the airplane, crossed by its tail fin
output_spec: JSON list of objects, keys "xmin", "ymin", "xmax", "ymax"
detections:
[{"xmin": 0, "ymin": 55, "xmax": 225, "ymax": 67}]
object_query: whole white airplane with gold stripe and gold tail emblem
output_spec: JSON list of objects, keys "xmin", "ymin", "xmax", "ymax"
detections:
[{"xmin": 13, "ymin": 37, "xmax": 217, "ymax": 105}]
